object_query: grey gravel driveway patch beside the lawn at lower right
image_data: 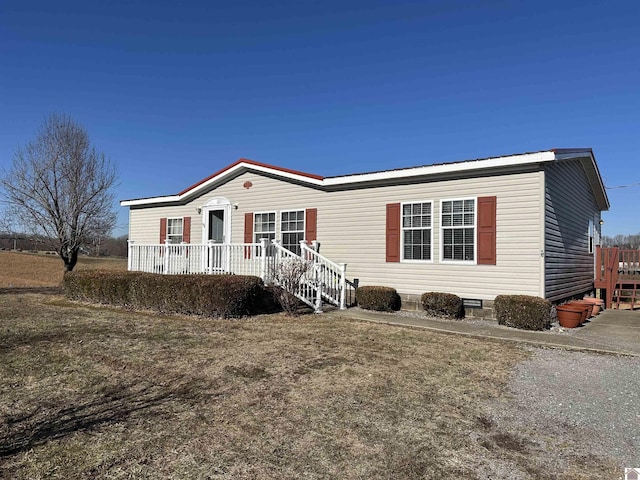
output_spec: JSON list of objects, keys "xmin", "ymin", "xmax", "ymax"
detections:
[{"xmin": 484, "ymin": 348, "xmax": 640, "ymax": 478}]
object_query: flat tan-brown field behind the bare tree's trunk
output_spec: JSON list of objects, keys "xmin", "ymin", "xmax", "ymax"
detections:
[{"xmin": 0, "ymin": 251, "xmax": 127, "ymax": 288}]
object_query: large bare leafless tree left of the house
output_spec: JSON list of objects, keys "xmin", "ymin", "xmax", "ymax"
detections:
[{"xmin": 0, "ymin": 114, "xmax": 117, "ymax": 271}]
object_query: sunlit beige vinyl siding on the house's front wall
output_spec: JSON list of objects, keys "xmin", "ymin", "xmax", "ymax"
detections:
[{"xmin": 130, "ymin": 171, "xmax": 544, "ymax": 300}]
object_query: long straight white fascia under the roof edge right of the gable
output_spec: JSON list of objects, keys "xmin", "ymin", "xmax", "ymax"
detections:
[{"xmin": 323, "ymin": 151, "xmax": 556, "ymax": 186}]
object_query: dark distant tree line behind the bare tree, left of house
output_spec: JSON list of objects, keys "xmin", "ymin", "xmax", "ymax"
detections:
[{"xmin": 0, "ymin": 231, "xmax": 127, "ymax": 257}]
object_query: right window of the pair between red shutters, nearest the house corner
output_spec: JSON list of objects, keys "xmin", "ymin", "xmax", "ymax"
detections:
[{"xmin": 440, "ymin": 198, "xmax": 476, "ymax": 262}]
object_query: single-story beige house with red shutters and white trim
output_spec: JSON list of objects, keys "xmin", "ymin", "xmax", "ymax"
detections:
[{"xmin": 120, "ymin": 148, "xmax": 609, "ymax": 314}]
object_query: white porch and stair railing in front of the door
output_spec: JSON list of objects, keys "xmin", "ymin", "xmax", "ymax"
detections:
[{"xmin": 128, "ymin": 239, "xmax": 347, "ymax": 313}]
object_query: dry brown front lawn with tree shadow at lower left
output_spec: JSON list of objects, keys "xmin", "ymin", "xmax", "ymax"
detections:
[{"xmin": 0, "ymin": 294, "xmax": 620, "ymax": 479}]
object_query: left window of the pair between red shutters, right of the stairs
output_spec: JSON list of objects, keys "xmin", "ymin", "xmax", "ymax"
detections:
[{"xmin": 401, "ymin": 202, "xmax": 433, "ymax": 261}]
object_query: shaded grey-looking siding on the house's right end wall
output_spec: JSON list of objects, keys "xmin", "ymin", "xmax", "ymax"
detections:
[{"xmin": 545, "ymin": 161, "xmax": 600, "ymax": 301}]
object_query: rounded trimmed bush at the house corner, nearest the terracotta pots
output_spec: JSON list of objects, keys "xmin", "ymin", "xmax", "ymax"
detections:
[{"xmin": 493, "ymin": 295, "xmax": 552, "ymax": 330}]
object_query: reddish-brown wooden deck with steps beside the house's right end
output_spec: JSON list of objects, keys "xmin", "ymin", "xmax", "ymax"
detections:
[{"xmin": 594, "ymin": 246, "xmax": 640, "ymax": 311}]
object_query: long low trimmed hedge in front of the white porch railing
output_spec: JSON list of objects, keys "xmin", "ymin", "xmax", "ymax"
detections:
[{"xmin": 63, "ymin": 270, "xmax": 275, "ymax": 318}]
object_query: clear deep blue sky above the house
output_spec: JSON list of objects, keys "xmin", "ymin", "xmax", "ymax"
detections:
[{"xmin": 0, "ymin": 0, "xmax": 640, "ymax": 235}]
